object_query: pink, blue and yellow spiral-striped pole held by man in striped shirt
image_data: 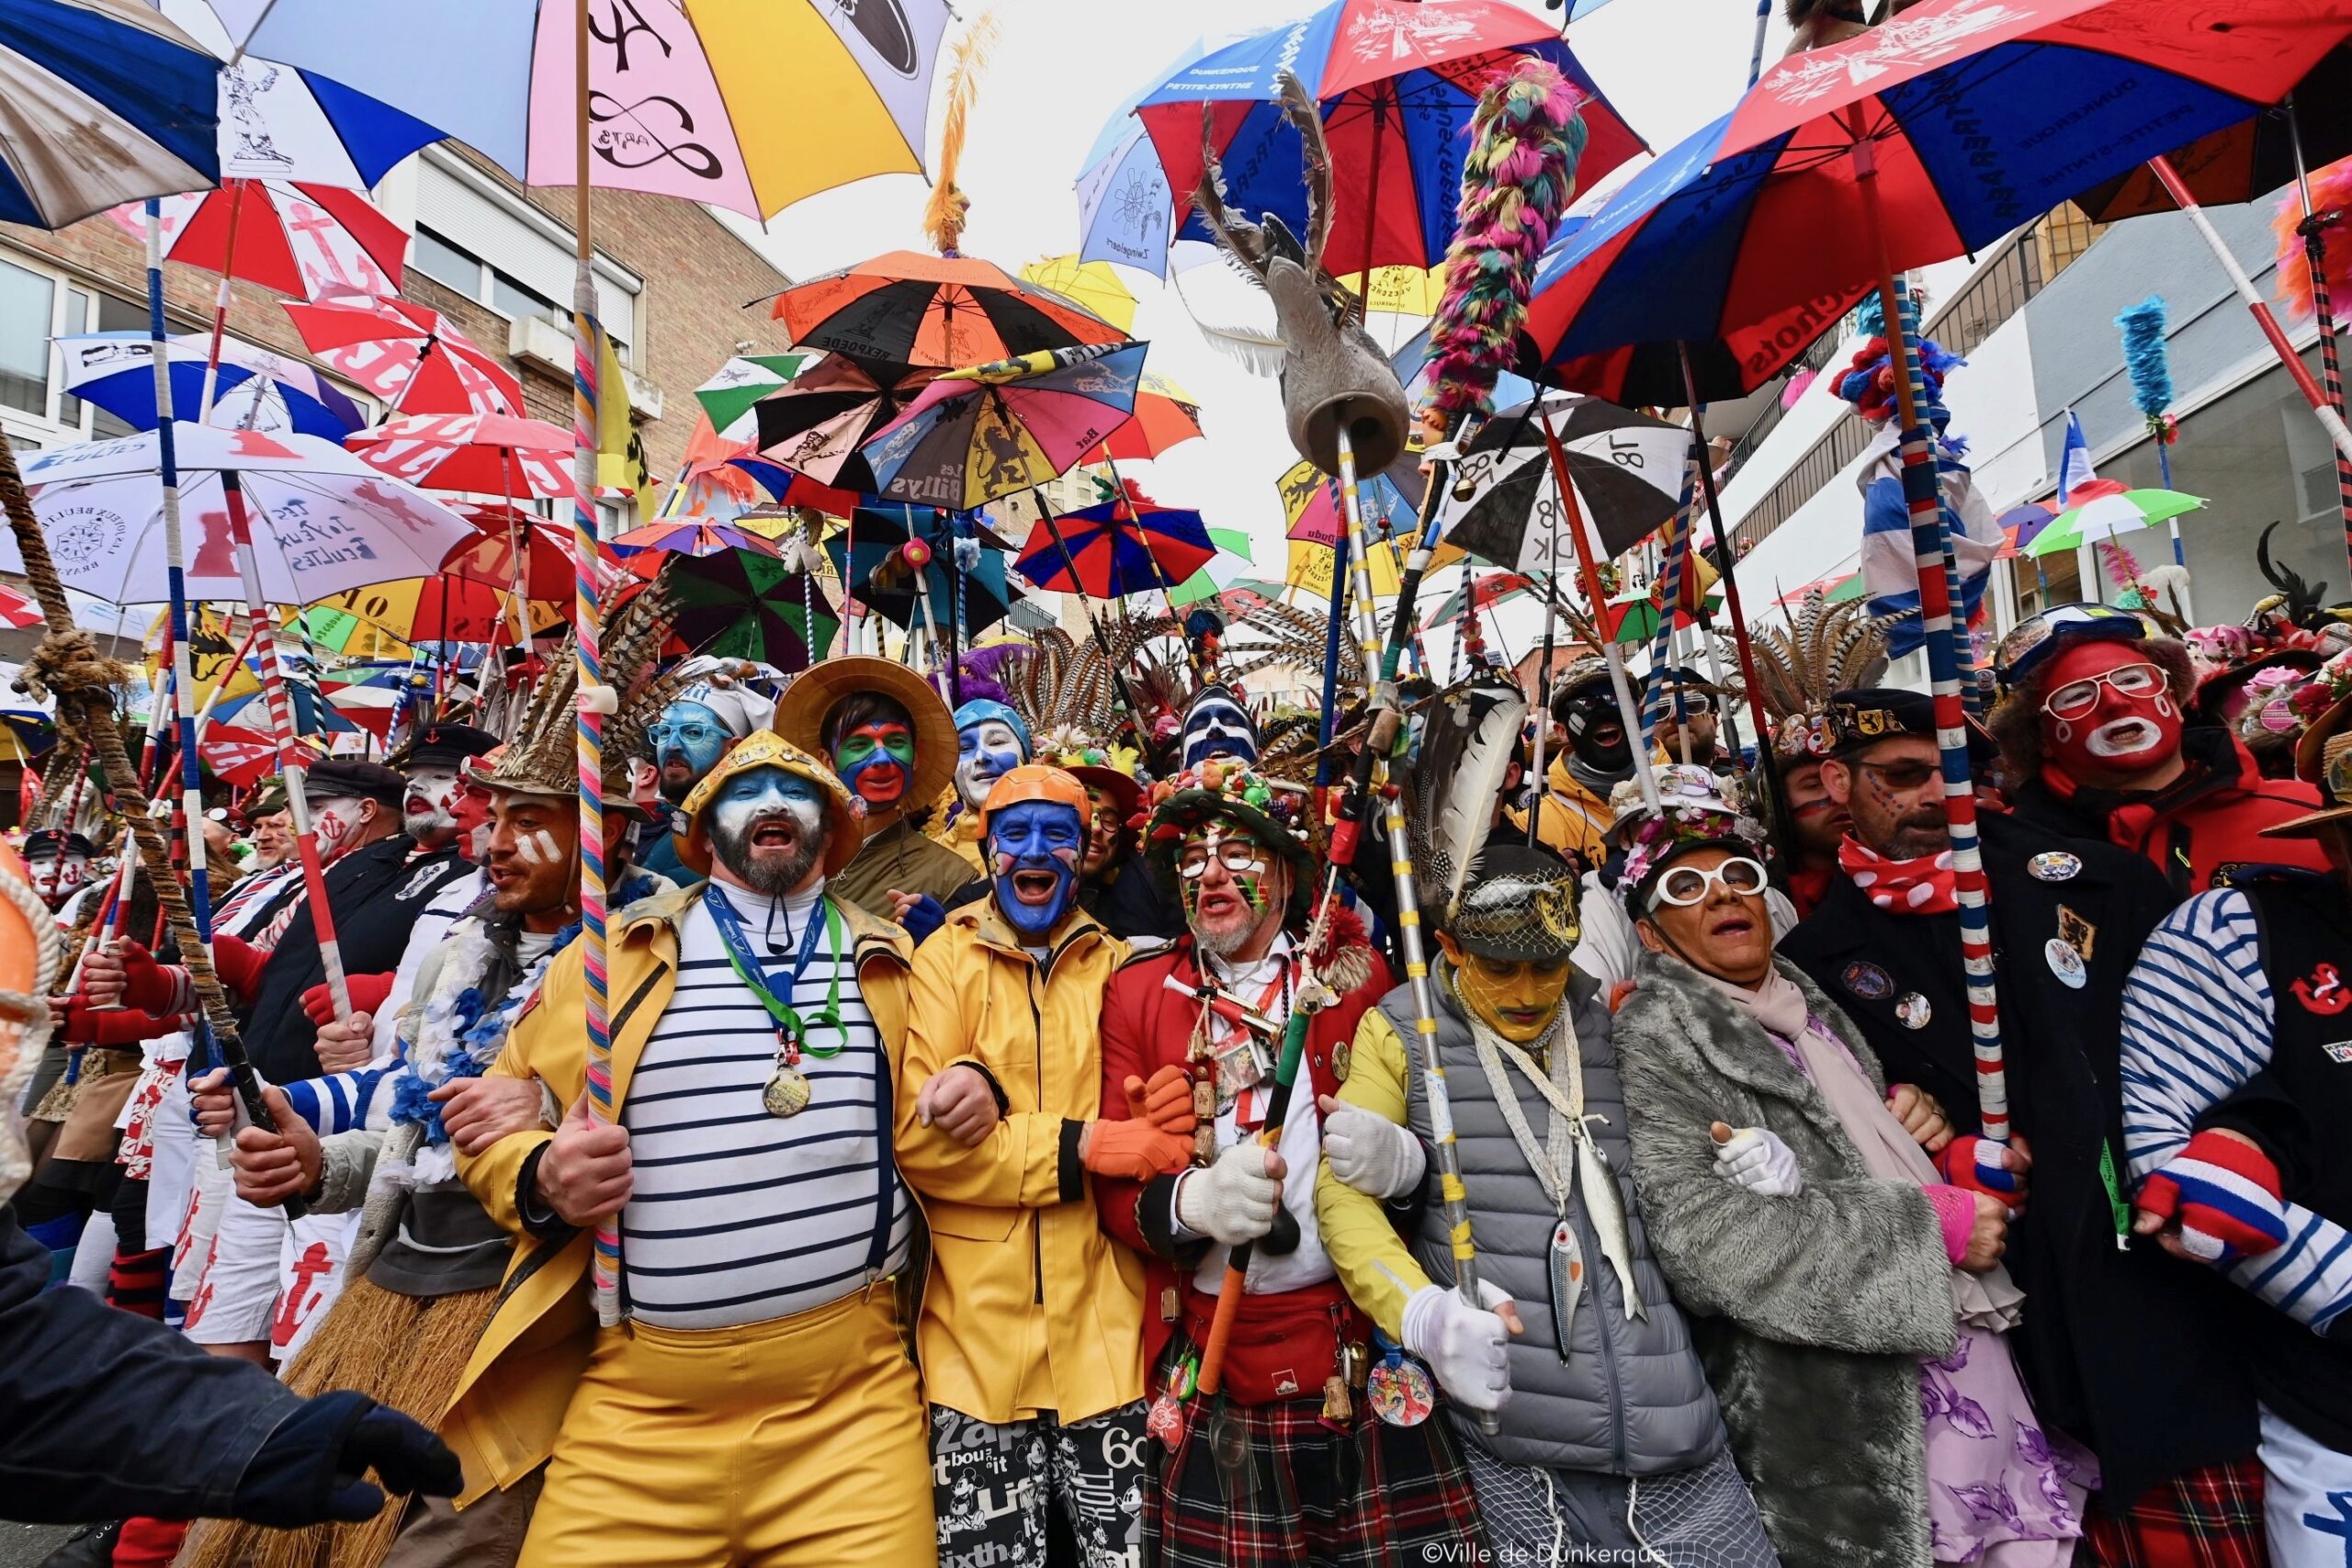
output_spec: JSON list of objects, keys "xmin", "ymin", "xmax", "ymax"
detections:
[{"xmin": 571, "ymin": 0, "xmax": 621, "ymax": 1328}]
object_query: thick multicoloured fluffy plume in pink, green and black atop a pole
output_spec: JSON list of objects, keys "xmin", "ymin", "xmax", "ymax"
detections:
[{"xmin": 1411, "ymin": 59, "xmax": 1588, "ymax": 423}]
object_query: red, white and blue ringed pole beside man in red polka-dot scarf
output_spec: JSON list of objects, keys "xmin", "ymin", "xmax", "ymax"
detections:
[{"xmin": 1853, "ymin": 136, "xmax": 2008, "ymax": 1145}]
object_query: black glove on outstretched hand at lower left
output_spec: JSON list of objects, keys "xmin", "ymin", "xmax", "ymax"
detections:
[{"xmin": 231, "ymin": 1389, "xmax": 463, "ymax": 1530}]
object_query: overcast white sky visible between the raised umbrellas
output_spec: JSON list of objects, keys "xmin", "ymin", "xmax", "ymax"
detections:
[{"xmin": 724, "ymin": 0, "xmax": 1785, "ymax": 611}]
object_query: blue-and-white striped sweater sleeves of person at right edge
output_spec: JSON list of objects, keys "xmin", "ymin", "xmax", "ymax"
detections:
[{"xmin": 2121, "ymin": 888, "xmax": 2352, "ymax": 1333}]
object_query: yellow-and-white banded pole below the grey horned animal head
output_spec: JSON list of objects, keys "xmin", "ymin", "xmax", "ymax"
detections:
[{"xmin": 1339, "ymin": 419, "xmax": 1496, "ymax": 1429}]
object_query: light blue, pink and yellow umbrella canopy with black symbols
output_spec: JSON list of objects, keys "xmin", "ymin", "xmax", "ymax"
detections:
[{"xmin": 211, "ymin": 0, "xmax": 948, "ymax": 219}]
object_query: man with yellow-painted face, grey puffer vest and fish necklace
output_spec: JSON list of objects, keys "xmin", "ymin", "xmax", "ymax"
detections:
[{"xmin": 1315, "ymin": 846, "xmax": 1778, "ymax": 1568}]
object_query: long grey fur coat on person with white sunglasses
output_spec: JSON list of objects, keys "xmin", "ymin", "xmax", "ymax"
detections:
[{"xmin": 1616, "ymin": 952, "xmax": 1957, "ymax": 1568}]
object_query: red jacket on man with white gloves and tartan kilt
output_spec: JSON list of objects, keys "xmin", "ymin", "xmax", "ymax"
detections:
[{"xmin": 1093, "ymin": 926, "xmax": 1390, "ymax": 1366}]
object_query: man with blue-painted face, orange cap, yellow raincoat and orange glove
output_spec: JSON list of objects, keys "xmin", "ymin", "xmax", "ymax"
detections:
[{"xmin": 899, "ymin": 764, "xmax": 1193, "ymax": 1568}]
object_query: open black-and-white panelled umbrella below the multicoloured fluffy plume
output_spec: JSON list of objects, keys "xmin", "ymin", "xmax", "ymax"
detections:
[{"xmin": 1440, "ymin": 392, "xmax": 1691, "ymax": 571}]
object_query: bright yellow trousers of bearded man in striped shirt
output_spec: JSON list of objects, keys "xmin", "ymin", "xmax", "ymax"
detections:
[{"xmin": 517, "ymin": 1281, "xmax": 938, "ymax": 1568}]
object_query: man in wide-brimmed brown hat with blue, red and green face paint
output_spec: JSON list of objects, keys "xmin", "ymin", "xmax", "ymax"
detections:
[{"xmin": 776, "ymin": 653, "xmax": 974, "ymax": 941}]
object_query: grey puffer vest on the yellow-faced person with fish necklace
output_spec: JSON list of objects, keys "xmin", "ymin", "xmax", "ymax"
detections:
[{"xmin": 1381, "ymin": 974, "xmax": 1726, "ymax": 1476}]
